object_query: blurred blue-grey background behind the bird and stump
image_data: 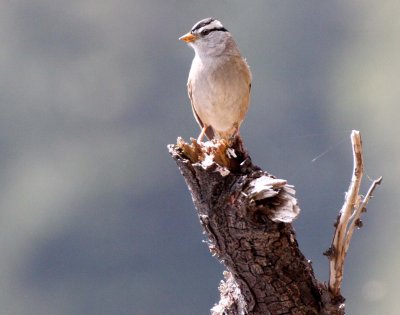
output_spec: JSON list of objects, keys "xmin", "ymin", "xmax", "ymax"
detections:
[{"xmin": 0, "ymin": 0, "xmax": 400, "ymax": 315}]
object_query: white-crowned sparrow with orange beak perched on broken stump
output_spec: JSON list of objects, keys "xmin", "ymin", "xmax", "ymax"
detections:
[{"xmin": 179, "ymin": 18, "xmax": 251, "ymax": 141}]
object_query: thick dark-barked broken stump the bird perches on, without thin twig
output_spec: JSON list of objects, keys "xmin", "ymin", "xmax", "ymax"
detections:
[{"xmin": 169, "ymin": 139, "xmax": 344, "ymax": 315}]
